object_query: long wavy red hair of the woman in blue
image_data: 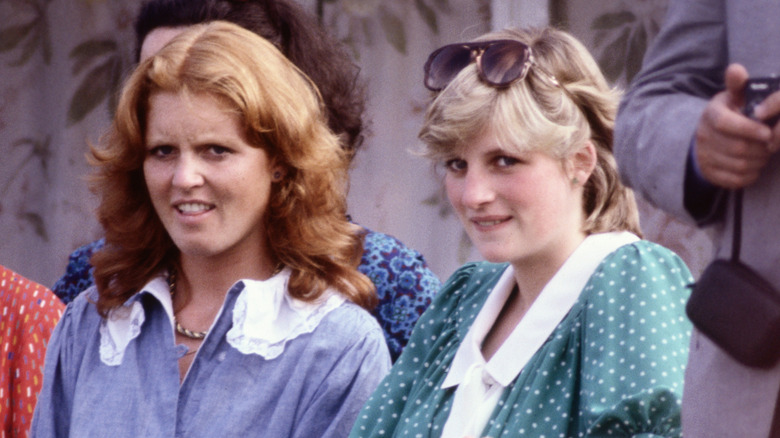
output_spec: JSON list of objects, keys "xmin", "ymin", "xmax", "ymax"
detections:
[{"xmin": 90, "ymin": 21, "xmax": 377, "ymax": 316}]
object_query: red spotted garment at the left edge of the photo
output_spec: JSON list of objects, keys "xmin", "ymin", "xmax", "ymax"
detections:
[{"xmin": 0, "ymin": 266, "xmax": 64, "ymax": 438}]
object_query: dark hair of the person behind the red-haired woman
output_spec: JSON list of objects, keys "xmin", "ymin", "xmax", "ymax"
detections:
[{"xmin": 135, "ymin": 0, "xmax": 365, "ymax": 159}]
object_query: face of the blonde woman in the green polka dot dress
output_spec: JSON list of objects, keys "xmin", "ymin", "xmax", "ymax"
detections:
[{"xmin": 445, "ymin": 131, "xmax": 584, "ymax": 265}]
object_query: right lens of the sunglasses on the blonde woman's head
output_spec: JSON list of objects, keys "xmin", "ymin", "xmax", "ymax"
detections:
[{"xmin": 480, "ymin": 41, "xmax": 529, "ymax": 86}]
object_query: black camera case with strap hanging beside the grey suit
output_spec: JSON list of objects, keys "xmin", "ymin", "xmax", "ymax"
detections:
[{"xmin": 685, "ymin": 190, "xmax": 780, "ymax": 368}]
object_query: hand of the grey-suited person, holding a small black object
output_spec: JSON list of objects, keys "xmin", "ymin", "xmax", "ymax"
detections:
[{"xmin": 694, "ymin": 64, "xmax": 780, "ymax": 189}]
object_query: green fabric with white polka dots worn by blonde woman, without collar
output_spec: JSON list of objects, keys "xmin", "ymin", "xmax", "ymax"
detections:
[{"xmin": 350, "ymin": 241, "xmax": 693, "ymax": 438}]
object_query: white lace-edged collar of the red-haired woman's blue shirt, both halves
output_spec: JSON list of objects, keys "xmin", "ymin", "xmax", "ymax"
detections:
[{"xmin": 100, "ymin": 268, "xmax": 345, "ymax": 366}]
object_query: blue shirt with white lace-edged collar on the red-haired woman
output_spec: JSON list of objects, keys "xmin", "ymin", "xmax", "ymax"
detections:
[{"xmin": 32, "ymin": 271, "xmax": 390, "ymax": 438}]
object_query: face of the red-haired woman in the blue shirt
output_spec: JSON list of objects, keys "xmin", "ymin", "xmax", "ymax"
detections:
[{"xmin": 143, "ymin": 92, "xmax": 281, "ymax": 264}]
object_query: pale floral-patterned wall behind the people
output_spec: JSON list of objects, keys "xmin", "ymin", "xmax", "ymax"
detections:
[{"xmin": 0, "ymin": 0, "xmax": 710, "ymax": 285}]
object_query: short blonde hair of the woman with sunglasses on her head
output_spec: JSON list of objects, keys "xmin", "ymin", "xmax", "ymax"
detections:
[{"xmin": 419, "ymin": 28, "xmax": 641, "ymax": 236}]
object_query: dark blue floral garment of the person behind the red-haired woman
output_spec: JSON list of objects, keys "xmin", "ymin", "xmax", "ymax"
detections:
[{"xmin": 52, "ymin": 224, "xmax": 441, "ymax": 361}]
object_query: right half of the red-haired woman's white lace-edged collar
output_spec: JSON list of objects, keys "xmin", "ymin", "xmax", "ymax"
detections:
[{"xmin": 227, "ymin": 270, "xmax": 345, "ymax": 360}]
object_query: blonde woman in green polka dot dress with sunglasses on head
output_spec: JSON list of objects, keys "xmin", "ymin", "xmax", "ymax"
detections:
[{"xmin": 350, "ymin": 29, "xmax": 692, "ymax": 438}]
